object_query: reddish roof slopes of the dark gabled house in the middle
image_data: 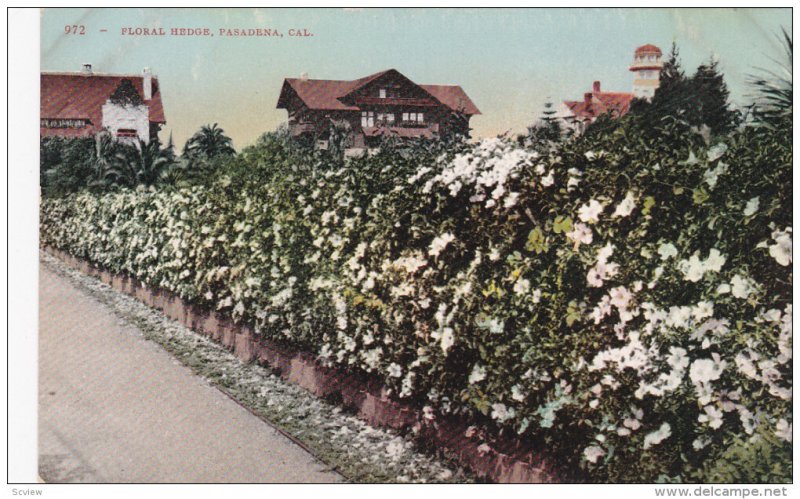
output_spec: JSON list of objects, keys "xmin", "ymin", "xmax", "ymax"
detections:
[{"xmin": 278, "ymin": 69, "xmax": 480, "ymax": 115}]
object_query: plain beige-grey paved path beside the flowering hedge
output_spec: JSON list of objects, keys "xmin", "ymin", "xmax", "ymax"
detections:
[{"xmin": 39, "ymin": 265, "xmax": 342, "ymax": 483}]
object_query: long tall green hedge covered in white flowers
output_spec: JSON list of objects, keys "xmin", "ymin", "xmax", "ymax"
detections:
[{"xmin": 41, "ymin": 115, "xmax": 792, "ymax": 482}]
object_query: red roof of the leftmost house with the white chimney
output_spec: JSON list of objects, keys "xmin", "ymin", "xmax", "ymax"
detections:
[{"xmin": 39, "ymin": 73, "xmax": 167, "ymax": 133}]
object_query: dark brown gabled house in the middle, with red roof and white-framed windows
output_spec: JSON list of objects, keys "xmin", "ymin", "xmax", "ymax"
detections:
[{"xmin": 277, "ymin": 69, "xmax": 480, "ymax": 148}]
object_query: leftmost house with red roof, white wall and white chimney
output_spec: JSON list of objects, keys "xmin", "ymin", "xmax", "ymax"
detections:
[{"xmin": 39, "ymin": 64, "xmax": 166, "ymax": 143}]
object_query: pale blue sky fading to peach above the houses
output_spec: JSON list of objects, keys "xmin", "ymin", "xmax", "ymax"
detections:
[{"xmin": 41, "ymin": 8, "xmax": 792, "ymax": 150}]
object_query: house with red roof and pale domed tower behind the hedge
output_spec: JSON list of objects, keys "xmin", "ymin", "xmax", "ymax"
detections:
[{"xmin": 558, "ymin": 44, "xmax": 663, "ymax": 133}]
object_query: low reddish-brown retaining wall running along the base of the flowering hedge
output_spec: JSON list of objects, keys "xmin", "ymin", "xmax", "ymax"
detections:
[{"xmin": 45, "ymin": 247, "xmax": 558, "ymax": 483}]
